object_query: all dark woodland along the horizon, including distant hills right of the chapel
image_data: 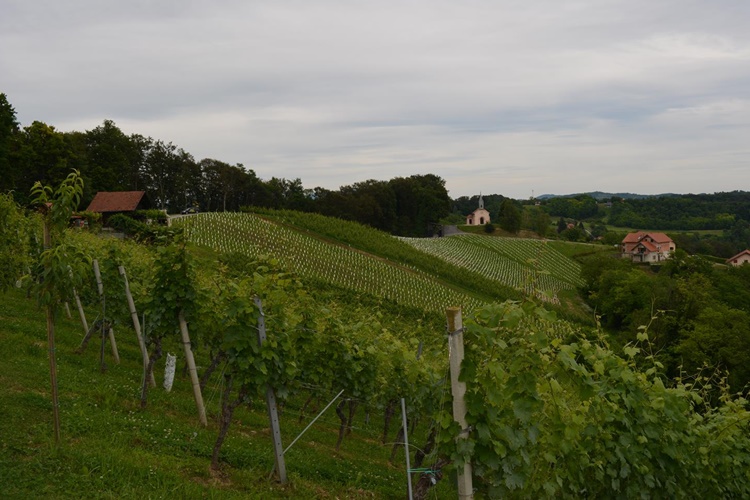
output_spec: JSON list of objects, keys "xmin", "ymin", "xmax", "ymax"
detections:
[{"xmin": 0, "ymin": 93, "xmax": 750, "ymax": 247}]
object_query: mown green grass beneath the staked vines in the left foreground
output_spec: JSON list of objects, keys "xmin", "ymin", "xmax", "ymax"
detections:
[{"xmin": 0, "ymin": 290, "xmax": 446, "ymax": 498}]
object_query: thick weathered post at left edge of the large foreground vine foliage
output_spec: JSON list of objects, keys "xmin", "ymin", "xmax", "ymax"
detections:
[{"xmin": 446, "ymin": 307, "xmax": 474, "ymax": 499}]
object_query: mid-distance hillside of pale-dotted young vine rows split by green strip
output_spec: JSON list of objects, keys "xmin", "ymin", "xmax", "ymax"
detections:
[{"xmin": 173, "ymin": 211, "xmax": 592, "ymax": 311}]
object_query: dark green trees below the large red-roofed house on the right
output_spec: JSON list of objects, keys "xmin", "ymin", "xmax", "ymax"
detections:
[{"xmin": 581, "ymin": 247, "xmax": 750, "ymax": 392}]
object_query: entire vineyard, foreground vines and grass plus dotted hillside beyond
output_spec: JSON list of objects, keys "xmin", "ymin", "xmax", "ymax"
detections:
[{"xmin": 0, "ymin": 180, "xmax": 750, "ymax": 498}]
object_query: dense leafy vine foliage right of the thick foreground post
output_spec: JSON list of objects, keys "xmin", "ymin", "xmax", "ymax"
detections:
[{"xmin": 444, "ymin": 303, "xmax": 750, "ymax": 498}]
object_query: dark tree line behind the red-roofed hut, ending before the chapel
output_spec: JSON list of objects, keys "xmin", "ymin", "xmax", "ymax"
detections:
[{"xmin": 0, "ymin": 93, "xmax": 451, "ymax": 236}]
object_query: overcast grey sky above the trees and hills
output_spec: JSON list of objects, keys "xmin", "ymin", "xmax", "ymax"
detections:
[{"xmin": 0, "ymin": 0, "xmax": 750, "ymax": 199}]
